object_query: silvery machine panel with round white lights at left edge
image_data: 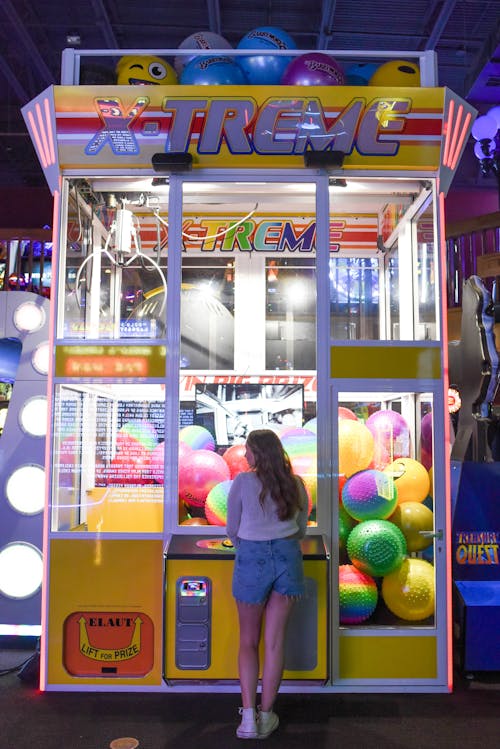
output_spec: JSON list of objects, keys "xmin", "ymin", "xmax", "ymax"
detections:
[{"xmin": 0, "ymin": 286, "xmax": 50, "ymax": 644}]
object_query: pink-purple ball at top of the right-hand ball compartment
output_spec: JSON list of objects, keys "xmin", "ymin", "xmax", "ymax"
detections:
[{"xmin": 365, "ymin": 409, "xmax": 410, "ymax": 470}]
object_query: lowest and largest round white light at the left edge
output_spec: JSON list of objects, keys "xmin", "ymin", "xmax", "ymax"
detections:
[{"xmin": 0, "ymin": 542, "xmax": 43, "ymax": 598}]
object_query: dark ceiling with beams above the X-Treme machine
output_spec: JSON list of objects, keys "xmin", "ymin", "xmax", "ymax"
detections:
[{"xmin": 0, "ymin": 0, "xmax": 500, "ymax": 187}]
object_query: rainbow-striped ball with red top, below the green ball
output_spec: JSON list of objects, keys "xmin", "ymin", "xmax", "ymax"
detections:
[{"xmin": 339, "ymin": 564, "xmax": 378, "ymax": 624}]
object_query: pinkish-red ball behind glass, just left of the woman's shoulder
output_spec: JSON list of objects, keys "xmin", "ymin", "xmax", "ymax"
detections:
[{"xmin": 179, "ymin": 450, "xmax": 230, "ymax": 507}]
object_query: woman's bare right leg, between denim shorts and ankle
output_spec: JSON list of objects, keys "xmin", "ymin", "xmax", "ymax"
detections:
[{"xmin": 261, "ymin": 590, "xmax": 294, "ymax": 712}]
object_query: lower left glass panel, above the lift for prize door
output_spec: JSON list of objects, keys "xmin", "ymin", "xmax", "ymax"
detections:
[{"xmin": 52, "ymin": 383, "xmax": 165, "ymax": 533}]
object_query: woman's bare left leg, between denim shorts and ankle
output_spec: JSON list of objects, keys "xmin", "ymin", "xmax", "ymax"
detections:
[{"xmin": 236, "ymin": 601, "xmax": 264, "ymax": 708}]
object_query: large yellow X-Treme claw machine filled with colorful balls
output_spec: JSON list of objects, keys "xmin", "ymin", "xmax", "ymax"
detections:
[{"xmin": 23, "ymin": 32, "xmax": 475, "ymax": 692}]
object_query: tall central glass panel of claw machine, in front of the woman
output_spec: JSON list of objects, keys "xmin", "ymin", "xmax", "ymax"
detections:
[{"xmin": 178, "ymin": 183, "xmax": 317, "ymax": 527}]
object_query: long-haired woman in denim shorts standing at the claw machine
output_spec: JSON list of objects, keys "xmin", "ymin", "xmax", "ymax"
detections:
[{"xmin": 227, "ymin": 429, "xmax": 308, "ymax": 739}]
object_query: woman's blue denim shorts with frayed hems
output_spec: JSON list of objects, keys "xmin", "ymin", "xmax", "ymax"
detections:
[{"xmin": 233, "ymin": 538, "xmax": 304, "ymax": 603}]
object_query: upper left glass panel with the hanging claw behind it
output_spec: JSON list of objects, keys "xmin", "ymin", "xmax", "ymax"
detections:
[{"xmin": 59, "ymin": 180, "xmax": 168, "ymax": 339}]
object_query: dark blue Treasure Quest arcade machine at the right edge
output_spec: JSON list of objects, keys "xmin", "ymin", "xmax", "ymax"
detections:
[{"xmin": 450, "ymin": 276, "xmax": 500, "ymax": 678}]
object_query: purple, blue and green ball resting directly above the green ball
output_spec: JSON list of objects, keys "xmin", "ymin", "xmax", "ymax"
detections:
[{"xmin": 342, "ymin": 469, "xmax": 398, "ymax": 520}]
